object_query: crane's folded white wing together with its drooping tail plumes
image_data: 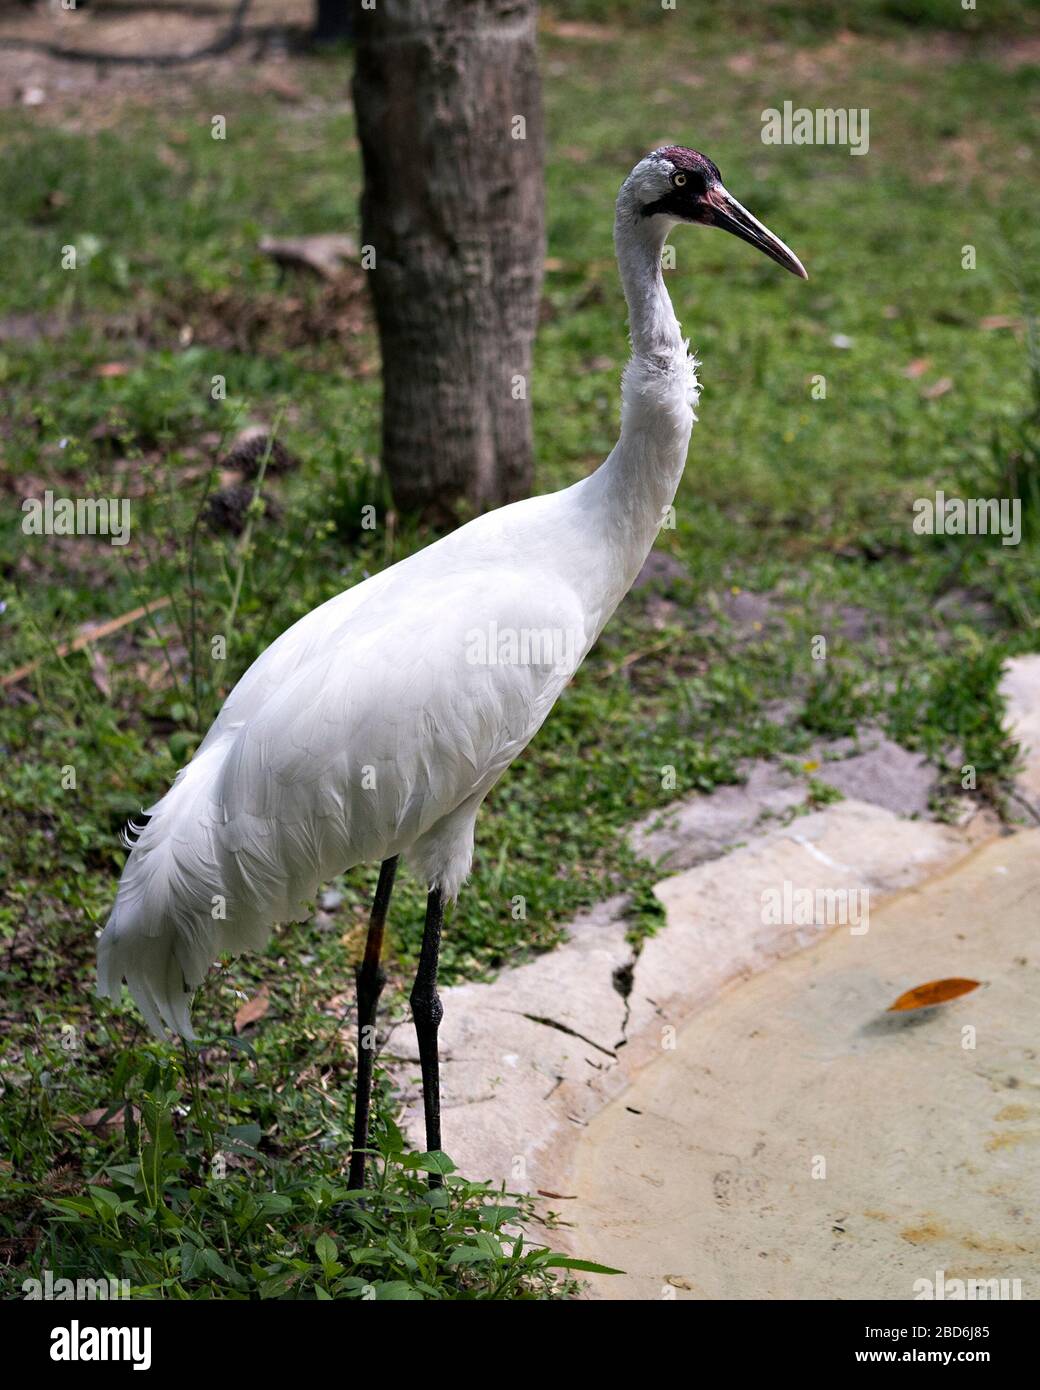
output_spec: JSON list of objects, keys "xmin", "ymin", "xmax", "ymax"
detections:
[{"xmin": 97, "ymin": 546, "xmax": 594, "ymax": 1037}]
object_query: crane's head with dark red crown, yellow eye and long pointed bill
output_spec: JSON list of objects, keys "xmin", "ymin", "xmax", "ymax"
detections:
[{"xmin": 621, "ymin": 145, "xmax": 809, "ymax": 279}]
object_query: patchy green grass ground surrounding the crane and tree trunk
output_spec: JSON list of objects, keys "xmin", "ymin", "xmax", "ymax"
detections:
[{"xmin": 0, "ymin": 0, "xmax": 1040, "ymax": 1297}]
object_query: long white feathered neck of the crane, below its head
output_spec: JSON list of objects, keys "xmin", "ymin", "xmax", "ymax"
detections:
[{"xmin": 575, "ymin": 186, "xmax": 698, "ymax": 619}]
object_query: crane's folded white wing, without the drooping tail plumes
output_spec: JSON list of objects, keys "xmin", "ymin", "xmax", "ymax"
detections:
[{"xmin": 211, "ymin": 571, "xmax": 588, "ymax": 920}]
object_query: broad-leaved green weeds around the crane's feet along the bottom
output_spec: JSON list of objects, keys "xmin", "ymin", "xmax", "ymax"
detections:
[{"xmin": 0, "ymin": 1043, "xmax": 610, "ymax": 1300}]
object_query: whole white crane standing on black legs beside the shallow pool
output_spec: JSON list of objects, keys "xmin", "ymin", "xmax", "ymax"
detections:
[{"xmin": 97, "ymin": 146, "xmax": 805, "ymax": 1187}]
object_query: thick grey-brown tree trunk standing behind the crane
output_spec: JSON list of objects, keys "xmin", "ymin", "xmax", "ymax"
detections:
[{"xmin": 355, "ymin": 0, "xmax": 544, "ymax": 523}]
